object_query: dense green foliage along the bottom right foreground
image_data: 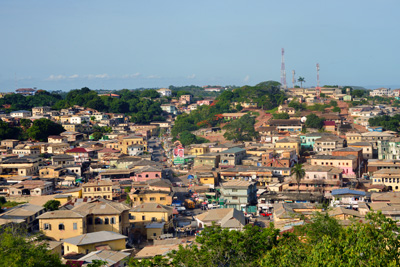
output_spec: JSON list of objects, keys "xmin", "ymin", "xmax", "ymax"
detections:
[{"xmin": 129, "ymin": 213, "xmax": 400, "ymax": 267}]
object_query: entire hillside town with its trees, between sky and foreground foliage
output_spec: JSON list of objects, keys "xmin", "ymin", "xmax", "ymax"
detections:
[{"xmin": 0, "ymin": 84, "xmax": 400, "ymax": 266}]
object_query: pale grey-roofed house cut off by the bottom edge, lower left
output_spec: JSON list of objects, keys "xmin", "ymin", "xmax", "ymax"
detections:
[{"xmin": 76, "ymin": 249, "xmax": 131, "ymax": 267}]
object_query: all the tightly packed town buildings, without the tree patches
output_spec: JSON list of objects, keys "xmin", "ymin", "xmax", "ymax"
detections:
[{"xmin": 0, "ymin": 88, "xmax": 400, "ymax": 266}]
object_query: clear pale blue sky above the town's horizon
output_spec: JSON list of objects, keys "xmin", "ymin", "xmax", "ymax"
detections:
[{"xmin": 0, "ymin": 0, "xmax": 400, "ymax": 92}]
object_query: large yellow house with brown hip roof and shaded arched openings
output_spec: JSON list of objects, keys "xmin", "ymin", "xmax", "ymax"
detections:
[{"xmin": 72, "ymin": 199, "xmax": 129, "ymax": 234}]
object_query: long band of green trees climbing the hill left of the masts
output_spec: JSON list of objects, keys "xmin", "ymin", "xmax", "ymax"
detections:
[{"xmin": 171, "ymin": 81, "xmax": 285, "ymax": 137}]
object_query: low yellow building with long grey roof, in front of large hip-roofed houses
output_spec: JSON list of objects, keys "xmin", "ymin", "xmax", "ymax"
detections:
[{"xmin": 64, "ymin": 231, "xmax": 127, "ymax": 254}]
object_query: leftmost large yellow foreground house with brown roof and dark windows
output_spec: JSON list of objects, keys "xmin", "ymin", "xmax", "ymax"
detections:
[{"xmin": 38, "ymin": 210, "xmax": 87, "ymax": 241}]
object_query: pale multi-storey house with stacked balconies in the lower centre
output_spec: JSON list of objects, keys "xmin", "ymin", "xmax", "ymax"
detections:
[{"xmin": 220, "ymin": 180, "xmax": 257, "ymax": 211}]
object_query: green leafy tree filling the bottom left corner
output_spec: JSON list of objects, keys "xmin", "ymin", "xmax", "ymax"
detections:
[{"xmin": 0, "ymin": 227, "xmax": 65, "ymax": 267}]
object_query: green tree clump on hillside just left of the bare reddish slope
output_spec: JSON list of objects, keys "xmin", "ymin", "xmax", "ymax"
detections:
[{"xmin": 223, "ymin": 114, "xmax": 258, "ymax": 142}]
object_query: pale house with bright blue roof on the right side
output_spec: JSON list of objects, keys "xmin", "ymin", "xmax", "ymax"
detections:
[{"xmin": 330, "ymin": 188, "xmax": 367, "ymax": 208}]
